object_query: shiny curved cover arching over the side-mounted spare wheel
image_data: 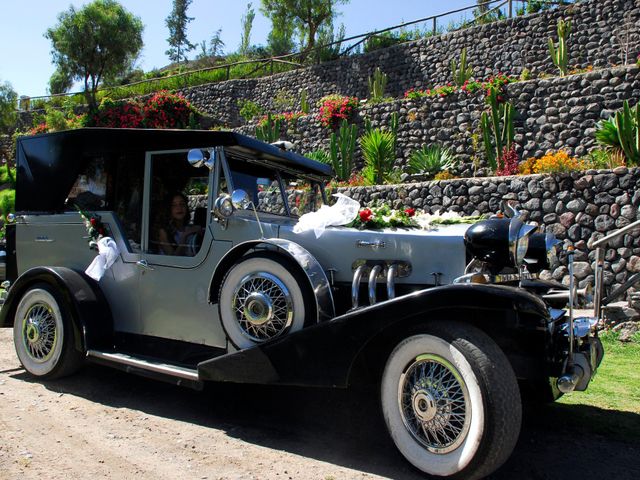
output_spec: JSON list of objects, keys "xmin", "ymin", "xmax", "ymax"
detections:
[{"xmin": 209, "ymin": 238, "xmax": 335, "ymax": 322}]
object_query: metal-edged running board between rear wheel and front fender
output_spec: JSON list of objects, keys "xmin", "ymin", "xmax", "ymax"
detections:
[{"xmin": 87, "ymin": 350, "xmax": 202, "ymax": 389}]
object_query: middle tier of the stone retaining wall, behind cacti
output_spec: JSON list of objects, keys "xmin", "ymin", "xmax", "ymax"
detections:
[{"xmin": 235, "ymin": 66, "xmax": 640, "ymax": 177}]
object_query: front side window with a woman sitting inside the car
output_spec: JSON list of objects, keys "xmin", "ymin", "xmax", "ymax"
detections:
[{"xmin": 147, "ymin": 151, "xmax": 209, "ymax": 257}]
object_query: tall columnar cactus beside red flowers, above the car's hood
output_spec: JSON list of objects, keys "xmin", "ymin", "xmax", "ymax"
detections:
[{"xmin": 480, "ymin": 88, "xmax": 515, "ymax": 171}]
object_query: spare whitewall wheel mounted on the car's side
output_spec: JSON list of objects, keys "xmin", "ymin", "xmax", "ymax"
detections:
[{"xmin": 218, "ymin": 252, "xmax": 314, "ymax": 348}]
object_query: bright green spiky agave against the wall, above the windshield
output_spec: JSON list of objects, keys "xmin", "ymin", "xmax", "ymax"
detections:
[{"xmin": 360, "ymin": 128, "xmax": 395, "ymax": 185}]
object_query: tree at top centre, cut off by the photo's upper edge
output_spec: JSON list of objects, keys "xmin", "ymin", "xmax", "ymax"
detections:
[{"xmin": 262, "ymin": 0, "xmax": 349, "ymax": 52}]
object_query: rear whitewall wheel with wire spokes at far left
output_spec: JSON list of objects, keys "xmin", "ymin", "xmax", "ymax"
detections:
[{"xmin": 13, "ymin": 284, "xmax": 82, "ymax": 379}]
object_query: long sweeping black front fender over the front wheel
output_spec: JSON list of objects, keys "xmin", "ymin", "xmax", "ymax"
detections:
[{"xmin": 198, "ymin": 284, "xmax": 549, "ymax": 387}]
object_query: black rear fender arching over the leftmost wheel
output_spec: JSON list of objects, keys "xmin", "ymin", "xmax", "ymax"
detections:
[{"xmin": 0, "ymin": 267, "xmax": 113, "ymax": 351}]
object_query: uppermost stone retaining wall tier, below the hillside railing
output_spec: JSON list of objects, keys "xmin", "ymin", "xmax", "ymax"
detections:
[{"xmin": 182, "ymin": 0, "xmax": 640, "ymax": 127}]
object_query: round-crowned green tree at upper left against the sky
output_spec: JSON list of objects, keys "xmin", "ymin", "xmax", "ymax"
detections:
[{"xmin": 44, "ymin": 0, "xmax": 144, "ymax": 109}]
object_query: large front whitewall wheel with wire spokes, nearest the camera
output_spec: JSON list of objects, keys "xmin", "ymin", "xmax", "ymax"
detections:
[{"xmin": 381, "ymin": 322, "xmax": 522, "ymax": 479}]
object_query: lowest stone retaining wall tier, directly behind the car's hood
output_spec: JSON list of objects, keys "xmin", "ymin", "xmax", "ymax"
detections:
[{"xmin": 339, "ymin": 167, "xmax": 640, "ymax": 288}]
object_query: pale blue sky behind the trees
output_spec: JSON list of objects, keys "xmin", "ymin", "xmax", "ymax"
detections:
[{"xmin": 0, "ymin": 0, "xmax": 475, "ymax": 97}]
